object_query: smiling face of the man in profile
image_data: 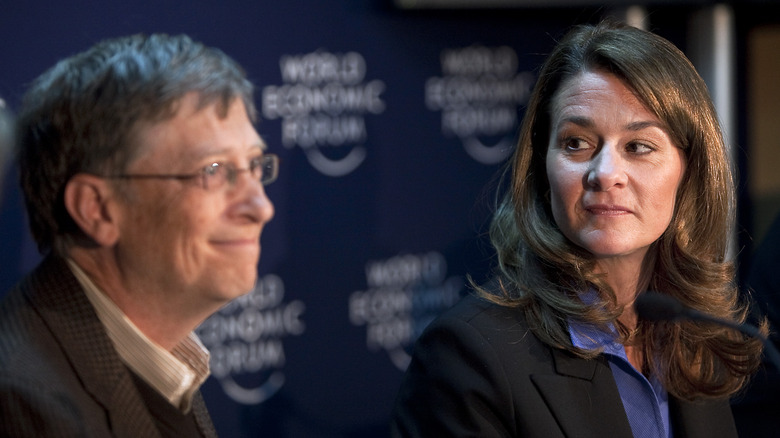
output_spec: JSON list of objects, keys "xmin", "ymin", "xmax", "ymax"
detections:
[{"xmin": 115, "ymin": 94, "xmax": 274, "ymax": 311}]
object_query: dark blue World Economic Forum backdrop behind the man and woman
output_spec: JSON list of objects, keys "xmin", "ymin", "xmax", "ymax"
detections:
[{"xmin": 0, "ymin": 0, "xmax": 684, "ymax": 437}]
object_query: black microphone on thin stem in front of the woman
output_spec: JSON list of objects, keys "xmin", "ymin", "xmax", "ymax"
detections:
[{"xmin": 634, "ymin": 292, "xmax": 780, "ymax": 370}]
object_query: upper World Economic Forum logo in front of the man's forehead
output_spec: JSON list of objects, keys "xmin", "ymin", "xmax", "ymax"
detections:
[{"xmin": 262, "ymin": 51, "xmax": 385, "ymax": 177}]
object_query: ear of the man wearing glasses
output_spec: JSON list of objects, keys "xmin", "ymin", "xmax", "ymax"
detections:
[{"xmin": 65, "ymin": 173, "xmax": 119, "ymax": 246}]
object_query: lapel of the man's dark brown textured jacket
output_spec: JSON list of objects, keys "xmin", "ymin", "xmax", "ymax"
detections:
[{"xmin": 23, "ymin": 256, "xmax": 159, "ymax": 437}]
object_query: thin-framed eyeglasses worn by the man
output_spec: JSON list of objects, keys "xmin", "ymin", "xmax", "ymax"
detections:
[{"xmin": 104, "ymin": 154, "xmax": 279, "ymax": 190}]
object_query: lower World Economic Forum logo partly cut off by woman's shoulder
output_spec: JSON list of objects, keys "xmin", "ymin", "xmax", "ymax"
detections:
[{"xmin": 349, "ymin": 251, "xmax": 463, "ymax": 371}]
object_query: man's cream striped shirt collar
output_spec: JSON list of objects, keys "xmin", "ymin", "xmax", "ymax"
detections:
[{"xmin": 68, "ymin": 259, "xmax": 209, "ymax": 413}]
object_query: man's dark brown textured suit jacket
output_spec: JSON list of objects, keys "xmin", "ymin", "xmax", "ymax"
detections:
[{"xmin": 0, "ymin": 256, "xmax": 216, "ymax": 438}]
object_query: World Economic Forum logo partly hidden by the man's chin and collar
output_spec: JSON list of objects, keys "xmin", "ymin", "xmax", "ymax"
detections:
[{"xmin": 197, "ymin": 274, "xmax": 306, "ymax": 405}]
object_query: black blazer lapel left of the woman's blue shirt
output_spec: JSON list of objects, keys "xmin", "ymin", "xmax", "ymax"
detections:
[{"xmin": 531, "ymin": 349, "xmax": 633, "ymax": 438}]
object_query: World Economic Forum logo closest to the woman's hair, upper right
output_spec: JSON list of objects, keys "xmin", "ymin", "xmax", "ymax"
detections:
[{"xmin": 425, "ymin": 45, "xmax": 534, "ymax": 164}]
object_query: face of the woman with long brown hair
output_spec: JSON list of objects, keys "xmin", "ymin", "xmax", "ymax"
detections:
[{"xmin": 547, "ymin": 71, "xmax": 685, "ymax": 263}]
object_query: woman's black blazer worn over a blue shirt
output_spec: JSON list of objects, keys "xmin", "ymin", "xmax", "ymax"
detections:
[{"xmin": 391, "ymin": 296, "xmax": 737, "ymax": 438}]
